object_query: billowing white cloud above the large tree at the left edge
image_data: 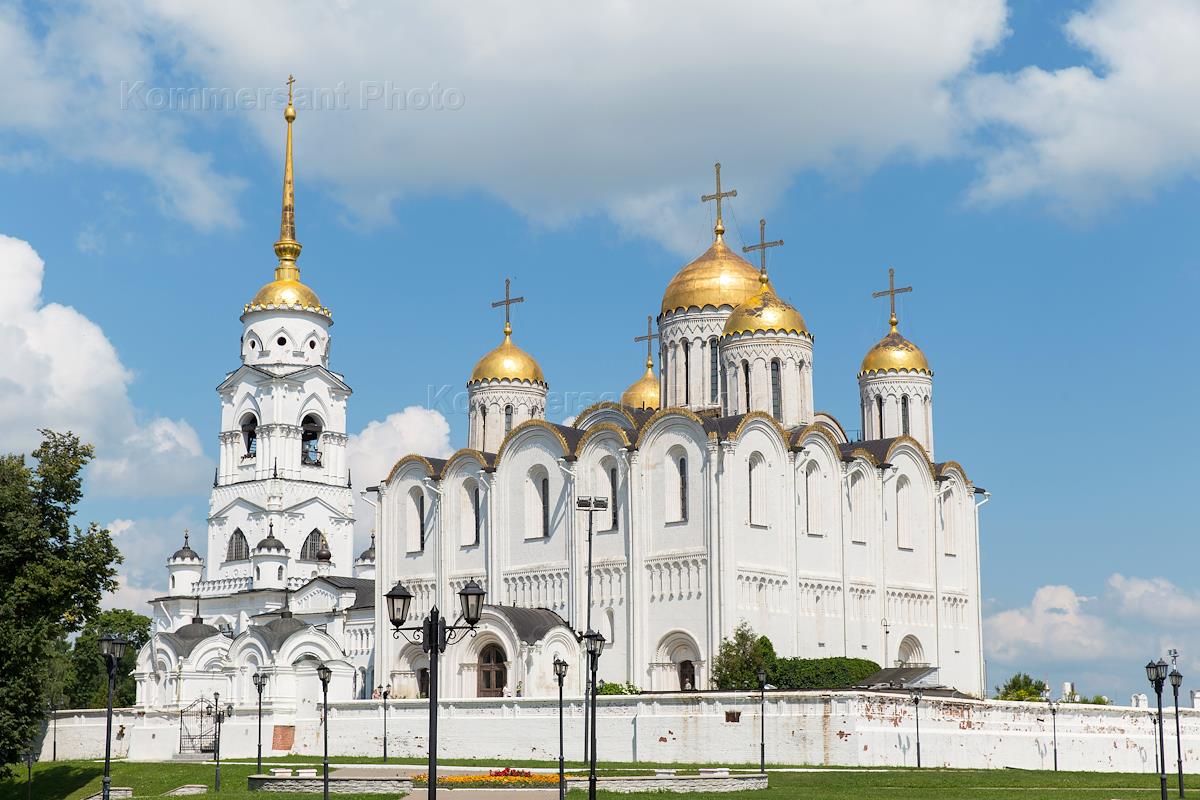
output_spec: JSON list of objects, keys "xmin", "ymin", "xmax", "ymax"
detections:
[{"xmin": 0, "ymin": 235, "xmax": 211, "ymax": 497}]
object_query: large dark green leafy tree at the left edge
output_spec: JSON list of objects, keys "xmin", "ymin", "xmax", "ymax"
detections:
[{"xmin": 0, "ymin": 431, "xmax": 121, "ymax": 776}]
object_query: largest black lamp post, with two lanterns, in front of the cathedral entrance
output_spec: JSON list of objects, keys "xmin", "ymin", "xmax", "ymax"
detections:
[{"xmin": 384, "ymin": 581, "xmax": 486, "ymax": 800}]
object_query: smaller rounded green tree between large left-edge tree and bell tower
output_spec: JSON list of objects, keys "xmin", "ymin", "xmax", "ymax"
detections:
[{"xmin": 66, "ymin": 608, "xmax": 150, "ymax": 709}]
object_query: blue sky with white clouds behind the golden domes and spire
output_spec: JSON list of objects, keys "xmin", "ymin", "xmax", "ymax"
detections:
[{"xmin": 0, "ymin": 0, "xmax": 1200, "ymax": 702}]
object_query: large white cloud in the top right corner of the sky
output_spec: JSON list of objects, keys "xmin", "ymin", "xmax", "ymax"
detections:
[{"xmin": 964, "ymin": 0, "xmax": 1200, "ymax": 213}]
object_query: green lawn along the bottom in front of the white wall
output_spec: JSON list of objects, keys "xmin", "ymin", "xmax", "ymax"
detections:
[{"xmin": 0, "ymin": 757, "xmax": 1200, "ymax": 800}]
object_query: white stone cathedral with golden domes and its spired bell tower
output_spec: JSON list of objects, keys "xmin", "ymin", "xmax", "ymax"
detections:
[{"xmin": 136, "ymin": 86, "xmax": 988, "ymax": 709}]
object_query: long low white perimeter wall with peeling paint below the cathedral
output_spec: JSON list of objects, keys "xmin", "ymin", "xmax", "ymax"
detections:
[{"xmin": 41, "ymin": 692, "xmax": 1200, "ymax": 772}]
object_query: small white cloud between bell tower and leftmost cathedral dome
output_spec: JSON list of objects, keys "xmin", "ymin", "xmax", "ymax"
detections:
[{"xmin": 347, "ymin": 405, "xmax": 454, "ymax": 543}]
